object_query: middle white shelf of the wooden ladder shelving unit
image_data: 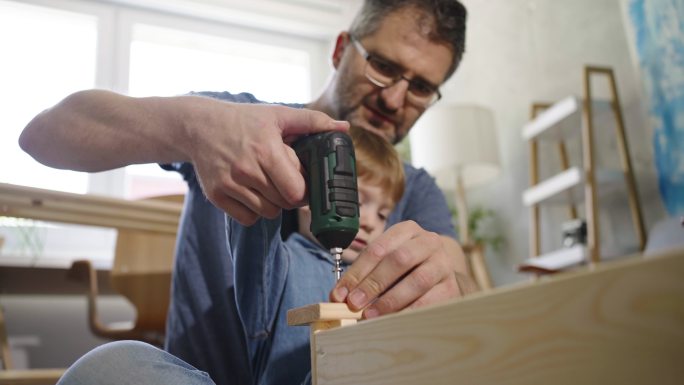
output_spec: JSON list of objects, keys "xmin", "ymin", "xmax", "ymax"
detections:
[{"xmin": 522, "ymin": 167, "xmax": 627, "ymax": 207}]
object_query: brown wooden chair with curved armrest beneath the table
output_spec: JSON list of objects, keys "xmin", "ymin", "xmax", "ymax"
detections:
[{"xmin": 69, "ymin": 196, "xmax": 183, "ymax": 346}]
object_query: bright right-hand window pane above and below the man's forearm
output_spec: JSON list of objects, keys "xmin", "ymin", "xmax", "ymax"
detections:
[{"xmin": 126, "ymin": 23, "xmax": 311, "ymax": 198}]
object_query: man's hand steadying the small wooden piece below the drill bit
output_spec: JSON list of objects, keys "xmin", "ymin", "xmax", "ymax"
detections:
[{"xmin": 330, "ymin": 221, "xmax": 473, "ymax": 318}]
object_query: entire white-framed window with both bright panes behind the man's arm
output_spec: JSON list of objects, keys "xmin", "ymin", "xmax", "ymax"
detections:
[{"xmin": 0, "ymin": 0, "xmax": 329, "ymax": 267}]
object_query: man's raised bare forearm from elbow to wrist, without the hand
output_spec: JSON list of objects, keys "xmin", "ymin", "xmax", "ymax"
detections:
[{"xmin": 19, "ymin": 90, "xmax": 188, "ymax": 172}]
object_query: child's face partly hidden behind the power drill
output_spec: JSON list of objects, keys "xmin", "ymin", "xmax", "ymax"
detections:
[{"xmin": 342, "ymin": 179, "xmax": 394, "ymax": 264}]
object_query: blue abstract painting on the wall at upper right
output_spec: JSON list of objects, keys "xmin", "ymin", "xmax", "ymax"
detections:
[{"xmin": 629, "ymin": 0, "xmax": 684, "ymax": 215}]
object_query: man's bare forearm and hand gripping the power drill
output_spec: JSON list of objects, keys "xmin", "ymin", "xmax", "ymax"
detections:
[{"xmin": 19, "ymin": 90, "xmax": 349, "ymax": 225}]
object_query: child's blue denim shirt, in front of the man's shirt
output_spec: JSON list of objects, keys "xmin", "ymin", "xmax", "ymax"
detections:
[{"xmin": 226, "ymin": 218, "xmax": 335, "ymax": 384}]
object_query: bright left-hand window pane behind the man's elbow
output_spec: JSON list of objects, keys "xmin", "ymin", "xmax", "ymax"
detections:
[{"xmin": 0, "ymin": 1, "xmax": 97, "ymax": 193}]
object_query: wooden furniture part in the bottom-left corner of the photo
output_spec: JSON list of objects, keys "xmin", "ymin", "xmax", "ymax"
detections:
[{"xmin": 0, "ymin": 308, "xmax": 64, "ymax": 385}]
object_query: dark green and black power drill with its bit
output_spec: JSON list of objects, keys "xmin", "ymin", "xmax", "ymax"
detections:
[{"xmin": 292, "ymin": 131, "xmax": 359, "ymax": 281}]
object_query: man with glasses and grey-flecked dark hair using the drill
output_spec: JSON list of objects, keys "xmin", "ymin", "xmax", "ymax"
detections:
[{"xmin": 20, "ymin": 0, "xmax": 468, "ymax": 384}]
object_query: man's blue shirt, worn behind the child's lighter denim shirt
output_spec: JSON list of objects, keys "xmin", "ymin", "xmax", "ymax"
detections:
[{"xmin": 162, "ymin": 92, "xmax": 455, "ymax": 385}]
